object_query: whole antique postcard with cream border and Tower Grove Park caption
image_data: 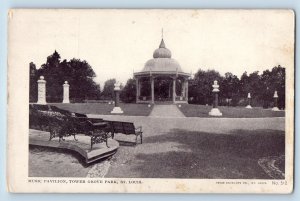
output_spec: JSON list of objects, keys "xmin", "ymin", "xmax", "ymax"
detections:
[{"xmin": 7, "ymin": 9, "xmax": 295, "ymax": 194}]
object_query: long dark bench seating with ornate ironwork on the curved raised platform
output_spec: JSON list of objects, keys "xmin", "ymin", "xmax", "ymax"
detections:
[{"xmin": 29, "ymin": 105, "xmax": 110, "ymax": 149}]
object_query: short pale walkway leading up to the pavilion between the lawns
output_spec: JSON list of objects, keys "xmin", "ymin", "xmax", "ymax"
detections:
[{"xmin": 149, "ymin": 105, "xmax": 185, "ymax": 117}]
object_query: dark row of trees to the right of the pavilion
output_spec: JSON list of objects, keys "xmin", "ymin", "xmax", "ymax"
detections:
[{"xmin": 189, "ymin": 65, "xmax": 285, "ymax": 108}]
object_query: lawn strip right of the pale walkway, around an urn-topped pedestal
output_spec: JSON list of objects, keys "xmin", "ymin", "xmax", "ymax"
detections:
[{"xmin": 178, "ymin": 104, "xmax": 285, "ymax": 118}]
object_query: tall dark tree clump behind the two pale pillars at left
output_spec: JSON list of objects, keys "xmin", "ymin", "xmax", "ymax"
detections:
[{"xmin": 30, "ymin": 51, "xmax": 100, "ymax": 102}]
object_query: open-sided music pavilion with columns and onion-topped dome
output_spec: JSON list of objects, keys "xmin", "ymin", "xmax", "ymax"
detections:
[{"xmin": 133, "ymin": 39, "xmax": 190, "ymax": 104}]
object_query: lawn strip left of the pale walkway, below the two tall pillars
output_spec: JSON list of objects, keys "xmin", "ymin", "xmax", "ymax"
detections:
[{"xmin": 49, "ymin": 103, "xmax": 152, "ymax": 116}]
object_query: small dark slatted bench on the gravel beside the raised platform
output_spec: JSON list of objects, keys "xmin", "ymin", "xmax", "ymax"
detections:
[{"xmin": 106, "ymin": 121, "xmax": 143, "ymax": 144}]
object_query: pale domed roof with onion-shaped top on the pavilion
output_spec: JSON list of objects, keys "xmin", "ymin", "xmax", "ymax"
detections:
[{"xmin": 142, "ymin": 39, "xmax": 182, "ymax": 72}]
